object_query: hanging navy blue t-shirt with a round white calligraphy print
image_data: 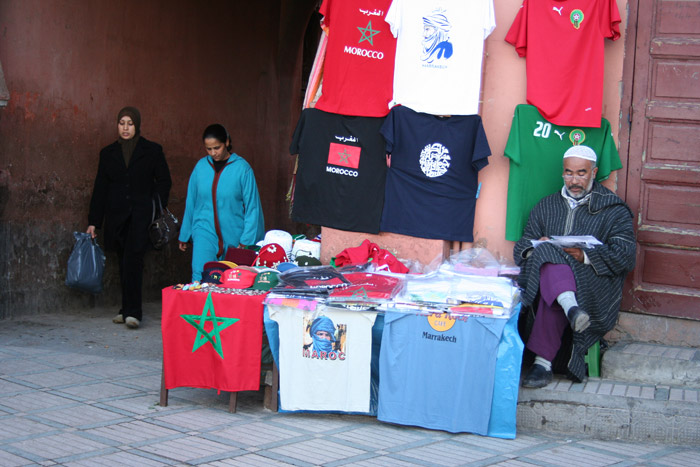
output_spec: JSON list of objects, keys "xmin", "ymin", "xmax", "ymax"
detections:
[{"xmin": 381, "ymin": 106, "xmax": 491, "ymax": 242}]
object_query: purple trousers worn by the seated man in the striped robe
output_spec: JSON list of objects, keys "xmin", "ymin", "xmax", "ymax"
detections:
[{"xmin": 527, "ymin": 263, "xmax": 576, "ymax": 362}]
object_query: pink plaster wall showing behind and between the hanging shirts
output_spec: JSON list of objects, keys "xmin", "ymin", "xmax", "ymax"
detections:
[{"xmin": 322, "ymin": 0, "xmax": 627, "ymax": 266}]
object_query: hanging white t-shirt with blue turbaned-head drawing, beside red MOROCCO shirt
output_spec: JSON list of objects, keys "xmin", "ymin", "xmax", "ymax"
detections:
[{"xmin": 386, "ymin": 0, "xmax": 496, "ymax": 115}]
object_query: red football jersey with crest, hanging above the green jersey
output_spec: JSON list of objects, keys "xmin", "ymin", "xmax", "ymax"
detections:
[{"xmin": 506, "ymin": 0, "xmax": 620, "ymax": 127}]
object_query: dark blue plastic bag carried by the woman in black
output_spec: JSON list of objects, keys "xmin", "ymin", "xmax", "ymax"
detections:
[{"xmin": 66, "ymin": 232, "xmax": 105, "ymax": 294}]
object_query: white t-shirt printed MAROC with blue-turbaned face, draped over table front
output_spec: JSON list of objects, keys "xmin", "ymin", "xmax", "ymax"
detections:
[{"xmin": 268, "ymin": 306, "xmax": 377, "ymax": 413}]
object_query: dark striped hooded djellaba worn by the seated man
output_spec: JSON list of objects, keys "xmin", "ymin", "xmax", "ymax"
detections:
[{"xmin": 513, "ymin": 182, "xmax": 636, "ymax": 381}]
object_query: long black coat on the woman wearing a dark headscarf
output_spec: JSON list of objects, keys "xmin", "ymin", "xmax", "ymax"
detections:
[{"xmin": 88, "ymin": 137, "xmax": 172, "ymax": 250}]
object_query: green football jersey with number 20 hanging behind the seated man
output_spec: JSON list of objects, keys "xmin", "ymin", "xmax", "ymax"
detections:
[{"xmin": 505, "ymin": 104, "xmax": 622, "ymax": 241}]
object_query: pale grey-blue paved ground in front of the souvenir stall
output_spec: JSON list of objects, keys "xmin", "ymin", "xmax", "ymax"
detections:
[{"xmin": 0, "ymin": 342, "xmax": 700, "ymax": 466}]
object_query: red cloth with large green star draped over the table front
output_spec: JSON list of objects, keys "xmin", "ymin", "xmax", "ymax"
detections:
[{"xmin": 162, "ymin": 287, "xmax": 265, "ymax": 391}]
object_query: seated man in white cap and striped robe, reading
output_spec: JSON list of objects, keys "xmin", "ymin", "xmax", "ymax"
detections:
[{"xmin": 513, "ymin": 146, "xmax": 636, "ymax": 388}]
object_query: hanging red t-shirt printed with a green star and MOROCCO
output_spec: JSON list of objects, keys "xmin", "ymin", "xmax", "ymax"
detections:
[{"xmin": 316, "ymin": 0, "xmax": 396, "ymax": 117}]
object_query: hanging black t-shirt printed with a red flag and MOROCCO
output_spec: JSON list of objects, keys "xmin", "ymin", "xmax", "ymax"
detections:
[{"xmin": 289, "ymin": 109, "xmax": 386, "ymax": 233}]
